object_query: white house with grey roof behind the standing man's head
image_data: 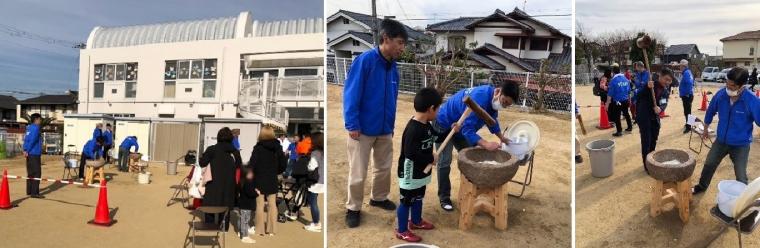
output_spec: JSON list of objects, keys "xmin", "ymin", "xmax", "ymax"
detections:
[{"xmin": 327, "ymin": 10, "xmax": 431, "ymax": 58}]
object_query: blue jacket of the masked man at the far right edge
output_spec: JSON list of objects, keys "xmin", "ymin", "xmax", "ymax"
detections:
[{"xmin": 705, "ymin": 88, "xmax": 760, "ymax": 146}]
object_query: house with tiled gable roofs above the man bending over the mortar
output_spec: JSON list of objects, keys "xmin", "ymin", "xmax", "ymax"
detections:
[{"xmin": 427, "ymin": 8, "xmax": 572, "ymax": 72}]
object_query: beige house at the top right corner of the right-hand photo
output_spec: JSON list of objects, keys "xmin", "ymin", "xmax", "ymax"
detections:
[{"xmin": 720, "ymin": 30, "xmax": 760, "ymax": 70}]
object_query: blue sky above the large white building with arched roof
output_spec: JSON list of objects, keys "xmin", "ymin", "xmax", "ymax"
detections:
[{"xmin": 0, "ymin": 0, "xmax": 324, "ymax": 98}]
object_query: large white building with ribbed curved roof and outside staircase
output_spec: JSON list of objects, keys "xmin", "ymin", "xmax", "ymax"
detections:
[{"xmin": 78, "ymin": 12, "xmax": 324, "ymax": 136}]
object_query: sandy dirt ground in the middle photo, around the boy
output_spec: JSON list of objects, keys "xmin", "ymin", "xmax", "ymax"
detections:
[{"xmin": 327, "ymin": 85, "xmax": 571, "ymax": 247}]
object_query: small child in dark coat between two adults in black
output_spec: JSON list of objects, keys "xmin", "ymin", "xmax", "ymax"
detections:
[{"xmin": 238, "ymin": 166, "xmax": 259, "ymax": 244}]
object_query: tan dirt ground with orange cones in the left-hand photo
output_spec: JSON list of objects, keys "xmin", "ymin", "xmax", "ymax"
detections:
[{"xmin": 0, "ymin": 156, "xmax": 325, "ymax": 247}]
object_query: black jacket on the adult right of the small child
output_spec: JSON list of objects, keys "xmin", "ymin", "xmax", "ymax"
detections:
[{"xmin": 248, "ymin": 139, "xmax": 288, "ymax": 195}]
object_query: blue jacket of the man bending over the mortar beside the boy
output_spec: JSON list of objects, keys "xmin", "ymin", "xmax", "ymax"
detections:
[{"xmin": 436, "ymin": 85, "xmax": 501, "ymax": 145}]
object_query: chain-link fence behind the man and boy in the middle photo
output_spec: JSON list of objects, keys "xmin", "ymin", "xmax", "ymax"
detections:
[{"xmin": 326, "ymin": 57, "xmax": 572, "ymax": 113}]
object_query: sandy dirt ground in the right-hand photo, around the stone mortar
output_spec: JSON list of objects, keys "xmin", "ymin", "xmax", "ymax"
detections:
[{"xmin": 575, "ymin": 86, "xmax": 760, "ymax": 247}]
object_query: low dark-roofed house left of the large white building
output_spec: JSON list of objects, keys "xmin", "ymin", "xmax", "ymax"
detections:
[{"xmin": 16, "ymin": 90, "xmax": 79, "ymax": 125}]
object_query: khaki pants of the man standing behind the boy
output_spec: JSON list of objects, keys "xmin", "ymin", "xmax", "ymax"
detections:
[{"xmin": 346, "ymin": 134, "xmax": 393, "ymax": 211}]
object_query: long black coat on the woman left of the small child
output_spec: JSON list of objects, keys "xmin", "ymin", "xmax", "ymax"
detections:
[{"xmin": 200, "ymin": 142, "xmax": 242, "ymax": 208}]
